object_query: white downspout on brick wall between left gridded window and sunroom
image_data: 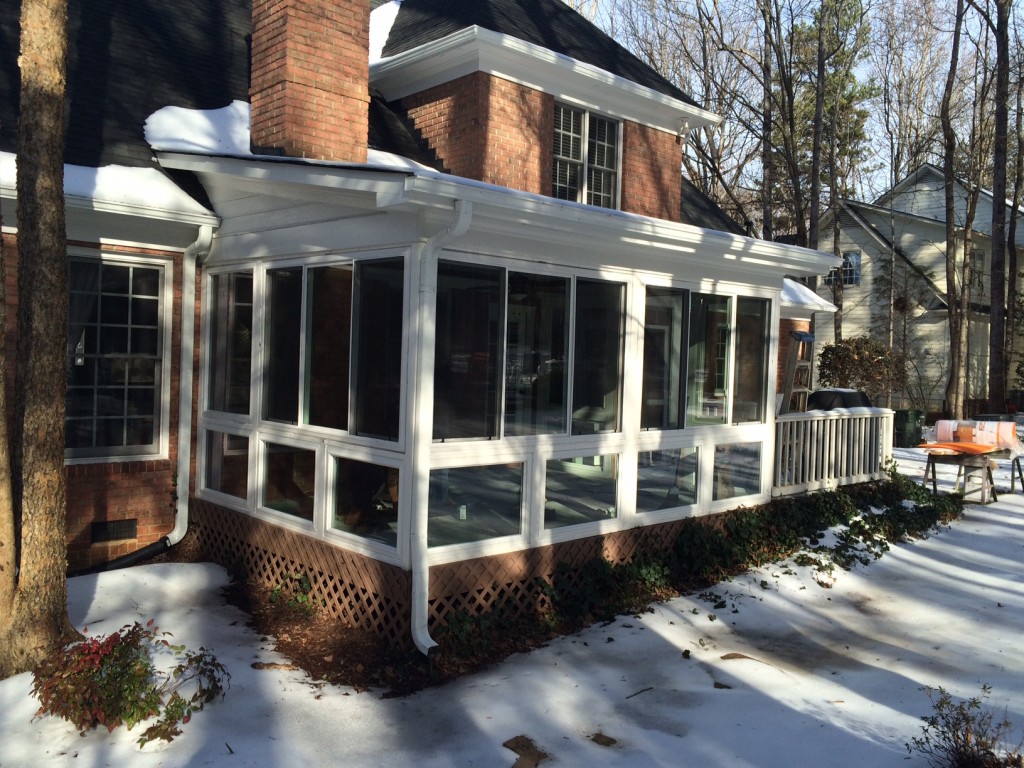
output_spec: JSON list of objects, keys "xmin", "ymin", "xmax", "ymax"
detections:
[{"xmin": 167, "ymin": 224, "xmax": 213, "ymax": 547}]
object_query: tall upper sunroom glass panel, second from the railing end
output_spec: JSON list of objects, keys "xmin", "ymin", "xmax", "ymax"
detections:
[{"xmin": 686, "ymin": 294, "xmax": 730, "ymax": 425}]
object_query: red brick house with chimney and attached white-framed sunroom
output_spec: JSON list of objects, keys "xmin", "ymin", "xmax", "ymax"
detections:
[{"xmin": 0, "ymin": 0, "xmax": 836, "ymax": 651}]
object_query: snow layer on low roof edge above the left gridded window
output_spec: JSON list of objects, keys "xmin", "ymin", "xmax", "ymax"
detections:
[{"xmin": 0, "ymin": 152, "xmax": 211, "ymax": 221}]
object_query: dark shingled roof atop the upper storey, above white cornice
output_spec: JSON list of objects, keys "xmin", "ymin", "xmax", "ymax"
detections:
[{"xmin": 371, "ymin": 0, "xmax": 698, "ymax": 106}]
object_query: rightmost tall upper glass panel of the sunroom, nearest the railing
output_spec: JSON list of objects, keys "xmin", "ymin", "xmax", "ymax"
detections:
[{"xmin": 732, "ymin": 296, "xmax": 771, "ymax": 422}]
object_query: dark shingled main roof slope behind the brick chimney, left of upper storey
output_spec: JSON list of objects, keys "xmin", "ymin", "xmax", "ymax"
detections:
[{"xmin": 0, "ymin": 0, "xmax": 431, "ymax": 168}]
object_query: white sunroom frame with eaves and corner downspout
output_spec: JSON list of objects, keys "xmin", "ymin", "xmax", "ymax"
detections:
[{"xmin": 160, "ymin": 153, "xmax": 836, "ymax": 651}]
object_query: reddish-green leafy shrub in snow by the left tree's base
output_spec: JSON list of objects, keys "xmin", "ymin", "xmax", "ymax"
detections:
[{"xmin": 32, "ymin": 620, "xmax": 230, "ymax": 745}]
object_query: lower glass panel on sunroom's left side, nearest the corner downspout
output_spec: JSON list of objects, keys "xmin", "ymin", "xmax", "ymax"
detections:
[{"xmin": 333, "ymin": 458, "xmax": 399, "ymax": 547}]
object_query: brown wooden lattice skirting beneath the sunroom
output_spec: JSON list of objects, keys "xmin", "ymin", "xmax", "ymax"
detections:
[{"xmin": 190, "ymin": 499, "xmax": 684, "ymax": 647}]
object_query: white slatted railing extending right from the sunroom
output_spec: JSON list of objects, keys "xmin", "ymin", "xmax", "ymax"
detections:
[{"xmin": 772, "ymin": 408, "xmax": 893, "ymax": 496}]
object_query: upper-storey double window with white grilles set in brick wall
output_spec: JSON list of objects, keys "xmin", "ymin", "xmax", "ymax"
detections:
[{"xmin": 551, "ymin": 103, "xmax": 618, "ymax": 208}]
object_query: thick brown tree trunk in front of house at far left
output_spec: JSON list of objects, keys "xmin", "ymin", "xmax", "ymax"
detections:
[{"xmin": 0, "ymin": 0, "xmax": 73, "ymax": 678}]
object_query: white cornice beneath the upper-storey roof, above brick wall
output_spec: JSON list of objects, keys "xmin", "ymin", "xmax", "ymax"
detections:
[{"xmin": 370, "ymin": 26, "xmax": 722, "ymax": 137}]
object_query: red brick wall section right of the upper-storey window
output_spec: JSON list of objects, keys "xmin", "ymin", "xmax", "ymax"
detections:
[{"xmin": 622, "ymin": 122, "xmax": 683, "ymax": 221}]
